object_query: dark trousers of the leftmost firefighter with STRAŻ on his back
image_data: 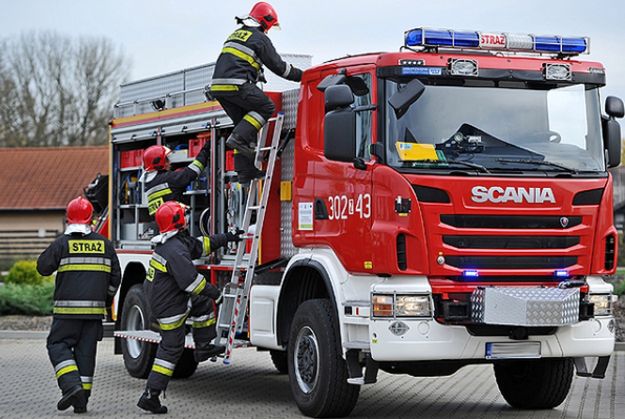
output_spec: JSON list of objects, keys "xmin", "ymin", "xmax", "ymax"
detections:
[{"xmin": 46, "ymin": 318, "xmax": 103, "ymax": 397}]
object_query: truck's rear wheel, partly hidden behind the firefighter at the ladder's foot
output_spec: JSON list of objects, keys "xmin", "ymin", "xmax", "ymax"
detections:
[{"xmin": 121, "ymin": 284, "xmax": 156, "ymax": 378}]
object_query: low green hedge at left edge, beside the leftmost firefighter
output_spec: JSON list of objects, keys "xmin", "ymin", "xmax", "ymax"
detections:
[{"xmin": 0, "ymin": 282, "xmax": 54, "ymax": 316}]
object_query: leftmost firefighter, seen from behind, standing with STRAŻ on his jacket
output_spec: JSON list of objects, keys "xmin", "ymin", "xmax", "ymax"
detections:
[{"xmin": 37, "ymin": 197, "xmax": 121, "ymax": 413}]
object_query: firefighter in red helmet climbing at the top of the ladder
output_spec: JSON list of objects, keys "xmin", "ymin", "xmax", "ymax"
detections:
[{"xmin": 209, "ymin": 2, "xmax": 302, "ymax": 184}]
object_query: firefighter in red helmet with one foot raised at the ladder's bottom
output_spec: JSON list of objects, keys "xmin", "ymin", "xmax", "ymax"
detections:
[{"xmin": 137, "ymin": 201, "xmax": 243, "ymax": 413}]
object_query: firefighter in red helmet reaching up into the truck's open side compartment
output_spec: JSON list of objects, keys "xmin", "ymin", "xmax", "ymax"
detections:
[{"xmin": 141, "ymin": 142, "xmax": 210, "ymax": 216}]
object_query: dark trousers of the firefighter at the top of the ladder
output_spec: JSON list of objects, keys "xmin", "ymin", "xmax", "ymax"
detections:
[{"xmin": 212, "ymin": 83, "xmax": 276, "ymax": 177}]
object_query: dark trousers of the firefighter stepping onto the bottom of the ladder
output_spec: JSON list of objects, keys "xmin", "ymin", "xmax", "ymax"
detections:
[{"xmin": 147, "ymin": 296, "xmax": 217, "ymax": 391}]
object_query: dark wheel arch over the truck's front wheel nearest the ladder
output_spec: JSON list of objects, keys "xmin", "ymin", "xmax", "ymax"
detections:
[{"xmin": 276, "ymin": 258, "xmax": 341, "ymax": 346}]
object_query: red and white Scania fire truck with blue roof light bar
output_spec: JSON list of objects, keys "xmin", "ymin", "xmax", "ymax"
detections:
[{"xmin": 108, "ymin": 28, "xmax": 624, "ymax": 417}]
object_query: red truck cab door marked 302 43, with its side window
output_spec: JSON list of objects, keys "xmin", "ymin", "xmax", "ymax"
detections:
[{"xmin": 314, "ymin": 67, "xmax": 376, "ymax": 272}]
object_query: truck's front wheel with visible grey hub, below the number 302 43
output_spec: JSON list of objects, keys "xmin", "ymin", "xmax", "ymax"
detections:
[{"xmin": 288, "ymin": 299, "xmax": 360, "ymax": 418}]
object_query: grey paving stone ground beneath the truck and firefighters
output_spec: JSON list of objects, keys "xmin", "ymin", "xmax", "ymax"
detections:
[{"xmin": 0, "ymin": 339, "xmax": 625, "ymax": 419}]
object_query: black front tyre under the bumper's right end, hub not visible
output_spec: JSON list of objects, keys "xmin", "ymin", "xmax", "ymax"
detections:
[{"xmin": 495, "ymin": 358, "xmax": 573, "ymax": 409}]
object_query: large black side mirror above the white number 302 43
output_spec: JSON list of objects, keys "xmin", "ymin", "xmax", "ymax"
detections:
[{"xmin": 323, "ymin": 107, "xmax": 356, "ymax": 163}]
